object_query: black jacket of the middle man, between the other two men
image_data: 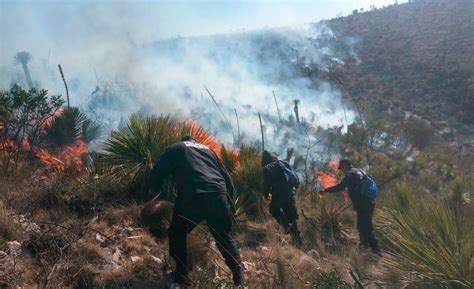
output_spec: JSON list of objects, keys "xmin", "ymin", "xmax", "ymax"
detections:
[{"xmin": 262, "ymin": 151, "xmax": 298, "ymax": 200}]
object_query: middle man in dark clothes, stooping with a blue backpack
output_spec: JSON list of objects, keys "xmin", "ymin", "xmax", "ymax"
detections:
[{"xmin": 262, "ymin": 150, "xmax": 301, "ymax": 243}]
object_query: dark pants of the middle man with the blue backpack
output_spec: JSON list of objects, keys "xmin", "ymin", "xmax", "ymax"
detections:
[{"xmin": 270, "ymin": 196, "xmax": 299, "ymax": 238}]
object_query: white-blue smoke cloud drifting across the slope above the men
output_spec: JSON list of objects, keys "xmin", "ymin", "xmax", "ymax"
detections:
[{"xmin": 0, "ymin": 2, "xmax": 355, "ymax": 152}]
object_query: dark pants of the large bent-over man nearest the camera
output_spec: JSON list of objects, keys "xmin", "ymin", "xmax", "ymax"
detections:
[{"xmin": 168, "ymin": 193, "xmax": 240, "ymax": 276}]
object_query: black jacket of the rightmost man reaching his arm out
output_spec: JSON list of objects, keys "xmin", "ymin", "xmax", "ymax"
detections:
[{"xmin": 323, "ymin": 168, "xmax": 374, "ymax": 210}]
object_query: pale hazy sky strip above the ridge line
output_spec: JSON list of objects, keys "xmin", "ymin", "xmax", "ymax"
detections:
[{"xmin": 0, "ymin": 0, "xmax": 402, "ymax": 64}]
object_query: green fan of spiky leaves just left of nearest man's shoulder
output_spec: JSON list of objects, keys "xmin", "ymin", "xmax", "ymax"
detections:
[{"xmin": 104, "ymin": 114, "xmax": 180, "ymax": 190}]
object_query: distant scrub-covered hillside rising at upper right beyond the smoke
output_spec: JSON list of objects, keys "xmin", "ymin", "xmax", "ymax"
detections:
[{"xmin": 327, "ymin": 0, "xmax": 474, "ymax": 139}]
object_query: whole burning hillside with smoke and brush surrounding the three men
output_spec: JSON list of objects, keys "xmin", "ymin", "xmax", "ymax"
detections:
[{"xmin": 0, "ymin": 0, "xmax": 474, "ymax": 289}]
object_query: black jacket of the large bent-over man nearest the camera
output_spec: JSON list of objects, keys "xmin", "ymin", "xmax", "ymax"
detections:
[{"xmin": 151, "ymin": 141, "xmax": 234, "ymax": 202}]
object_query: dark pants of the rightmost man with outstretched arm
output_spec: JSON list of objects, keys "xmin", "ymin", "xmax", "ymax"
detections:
[{"xmin": 356, "ymin": 201, "xmax": 380, "ymax": 252}]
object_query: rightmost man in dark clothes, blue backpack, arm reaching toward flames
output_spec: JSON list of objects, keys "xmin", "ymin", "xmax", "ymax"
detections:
[{"xmin": 319, "ymin": 159, "xmax": 380, "ymax": 255}]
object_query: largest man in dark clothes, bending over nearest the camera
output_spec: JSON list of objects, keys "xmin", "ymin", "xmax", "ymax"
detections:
[{"xmin": 151, "ymin": 136, "xmax": 243, "ymax": 285}]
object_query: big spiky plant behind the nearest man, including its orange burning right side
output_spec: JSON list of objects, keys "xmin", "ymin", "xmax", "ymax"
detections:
[{"xmin": 102, "ymin": 114, "xmax": 243, "ymax": 200}]
